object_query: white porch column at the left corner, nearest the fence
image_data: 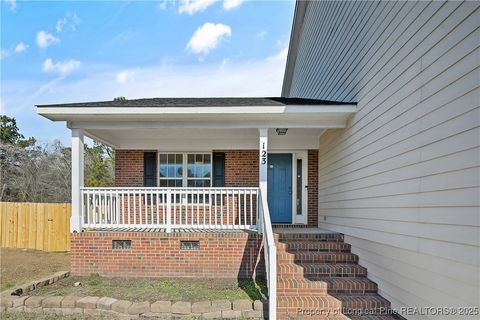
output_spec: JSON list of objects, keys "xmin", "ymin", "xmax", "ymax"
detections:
[{"xmin": 70, "ymin": 129, "xmax": 84, "ymax": 232}]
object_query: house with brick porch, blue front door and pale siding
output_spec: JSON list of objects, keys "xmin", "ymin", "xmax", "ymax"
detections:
[{"xmin": 37, "ymin": 1, "xmax": 480, "ymax": 319}]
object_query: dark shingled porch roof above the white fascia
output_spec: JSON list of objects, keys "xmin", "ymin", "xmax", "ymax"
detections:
[{"xmin": 37, "ymin": 97, "xmax": 352, "ymax": 108}]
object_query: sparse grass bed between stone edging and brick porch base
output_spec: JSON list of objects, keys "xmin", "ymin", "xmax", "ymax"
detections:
[{"xmin": 31, "ymin": 275, "xmax": 267, "ymax": 302}]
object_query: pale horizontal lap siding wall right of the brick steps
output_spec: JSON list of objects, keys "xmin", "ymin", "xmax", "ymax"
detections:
[{"xmin": 289, "ymin": 2, "xmax": 480, "ymax": 318}]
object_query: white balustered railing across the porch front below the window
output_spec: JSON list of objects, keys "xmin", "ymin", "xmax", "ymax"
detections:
[{"xmin": 80, "ymin": 188, "xmax": 259, "ymax": 232}]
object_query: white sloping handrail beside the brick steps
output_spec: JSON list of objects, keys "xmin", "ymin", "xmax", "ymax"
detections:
[{"xmin": 257, "ymin": 182, "xmax": 277, "ymax": 320}]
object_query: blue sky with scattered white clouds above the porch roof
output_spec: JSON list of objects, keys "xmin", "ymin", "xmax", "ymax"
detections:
[{"xmin": 0, "ymin": 0, "xmax": 294, "ymax": 144}]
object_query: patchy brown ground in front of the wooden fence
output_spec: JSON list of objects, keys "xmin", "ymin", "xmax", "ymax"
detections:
[{"xmin": 0, "ymin": 248, "xmax": 70, "ymax": 291}]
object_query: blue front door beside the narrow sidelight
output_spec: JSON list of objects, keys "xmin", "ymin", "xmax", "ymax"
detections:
[{"xmin": 267, "ymin": 153, "xmax": 292, "ymax": 223}]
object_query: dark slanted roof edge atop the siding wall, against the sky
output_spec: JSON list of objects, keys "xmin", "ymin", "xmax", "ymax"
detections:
[{"xmin": 281, "ymin": 0, "xmax": 308, "ymax": 97}]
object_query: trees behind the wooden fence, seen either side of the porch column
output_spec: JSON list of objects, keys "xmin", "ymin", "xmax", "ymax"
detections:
[{"xmin": 0, "ymin": 116, "xmax": 114, "ymax": 202}]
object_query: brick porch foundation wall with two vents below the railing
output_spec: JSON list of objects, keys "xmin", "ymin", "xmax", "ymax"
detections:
[{"xmin": 70, "ymin": 231, "xmax": 264, "ymax": 278}]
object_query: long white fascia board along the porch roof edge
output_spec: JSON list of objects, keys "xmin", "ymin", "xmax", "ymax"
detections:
[{"xmin": 37, "ymin": 104, "xmax": 357, "ymax": 117}]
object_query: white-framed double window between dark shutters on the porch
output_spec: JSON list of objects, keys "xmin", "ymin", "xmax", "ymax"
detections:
[{"xmin": 158, "ymin": 153, "xmax": 212, "ymax": 188}]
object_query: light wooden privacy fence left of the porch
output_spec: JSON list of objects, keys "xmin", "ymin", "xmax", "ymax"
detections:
[{"xmin": 0, "ymin": 202, "xmax": 71, "ymax": 251}]
